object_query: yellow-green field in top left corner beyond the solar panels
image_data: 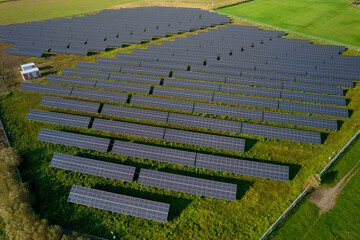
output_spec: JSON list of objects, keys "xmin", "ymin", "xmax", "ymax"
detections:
[{"xmin": 0, "ymin": 0, "xmax": 140, "ymax": 25}]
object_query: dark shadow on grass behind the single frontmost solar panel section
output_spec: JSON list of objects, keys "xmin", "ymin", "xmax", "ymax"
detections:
[{"xmin": 92, "ymin": 183, "xmax": 192, "ymax": 221}]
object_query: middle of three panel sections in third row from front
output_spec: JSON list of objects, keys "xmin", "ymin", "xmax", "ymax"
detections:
[{"xmin": 111, "ymin": 141, "xmax": 196, "ymax": 166}]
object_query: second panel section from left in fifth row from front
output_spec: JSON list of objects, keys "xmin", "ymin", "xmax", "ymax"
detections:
[{"xmin": 101, "ymin": 104, "xmax": 169, "ymax": 122}]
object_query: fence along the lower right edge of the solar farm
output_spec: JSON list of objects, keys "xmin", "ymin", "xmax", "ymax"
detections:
[{"xmin": 259, "ymin": 130, "xmax": 360, "ymax": 240}]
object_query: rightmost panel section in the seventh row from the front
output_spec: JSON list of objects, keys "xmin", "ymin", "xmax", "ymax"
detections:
[{"xmin": 279, "ymin": 101, "xmax": 349, "ymax": 118}]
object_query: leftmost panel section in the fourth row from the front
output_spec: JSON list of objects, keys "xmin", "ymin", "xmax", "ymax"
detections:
[{"xmin": 26, "ymin": 109, "xmax": 91, "ymax": 128}]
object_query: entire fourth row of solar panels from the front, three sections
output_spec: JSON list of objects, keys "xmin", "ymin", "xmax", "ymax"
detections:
[{"xmin": 26, "ymin": 110, "xmax": 248, "ymax": 152}]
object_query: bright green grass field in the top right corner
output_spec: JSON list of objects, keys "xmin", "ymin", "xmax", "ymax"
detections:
[{"xmin": 218, "ymin": 0, "xmax": 360, "ymax": 48}]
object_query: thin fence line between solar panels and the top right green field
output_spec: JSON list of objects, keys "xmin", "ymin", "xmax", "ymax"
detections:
[{"xmin": 214, "ymin": 11, "xmax": 360, "ymax": 51}]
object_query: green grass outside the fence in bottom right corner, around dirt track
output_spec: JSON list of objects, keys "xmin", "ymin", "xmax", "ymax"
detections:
[{"xmin": 271, "ymin": 137, "xmax": 360, "ymax": 239}]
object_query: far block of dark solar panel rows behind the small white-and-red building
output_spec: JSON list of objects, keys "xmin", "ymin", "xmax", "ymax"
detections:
[{"xmin": 0, "ymin": 8, "xmax": 228, "ymax": 57}]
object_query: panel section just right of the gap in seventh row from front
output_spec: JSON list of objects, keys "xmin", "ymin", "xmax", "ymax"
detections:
[{"xmin": 152, "ymin": 87, "xmax": 213, "ymax": 101}]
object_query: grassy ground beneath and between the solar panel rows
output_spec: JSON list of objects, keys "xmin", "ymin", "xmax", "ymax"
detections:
[{"xmin": 0, "ymin": 6, "xmax": 360, "ymax": 239}]
